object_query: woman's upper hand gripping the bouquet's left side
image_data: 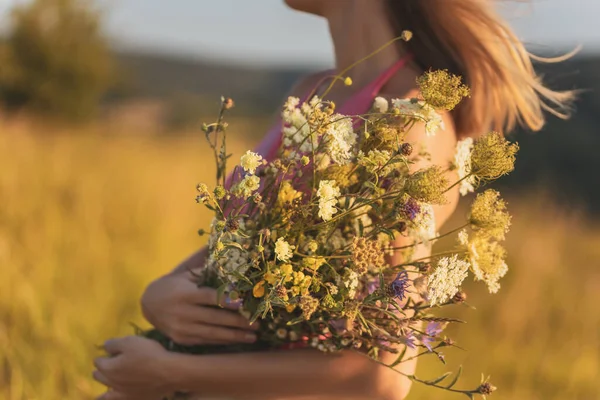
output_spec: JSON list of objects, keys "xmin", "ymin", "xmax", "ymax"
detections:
[{"xmin": 142, "ymin": 272, "xmax": 258, "ymax": 345}]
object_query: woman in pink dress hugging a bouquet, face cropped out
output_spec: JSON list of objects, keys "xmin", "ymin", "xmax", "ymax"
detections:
[{"xmin": 94, "ymin": 0, "xmax": 571, "ymax": 400}]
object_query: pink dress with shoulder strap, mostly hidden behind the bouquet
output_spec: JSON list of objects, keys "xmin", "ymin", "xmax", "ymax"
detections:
[{"xmin": 255, "ymin": 56, "xmax": 412, "ymax": 161}]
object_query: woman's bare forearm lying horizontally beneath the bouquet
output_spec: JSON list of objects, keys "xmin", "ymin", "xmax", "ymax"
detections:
[{"xmin": 169, "ymin": 350, "xmax": 410, "ymax": 400}]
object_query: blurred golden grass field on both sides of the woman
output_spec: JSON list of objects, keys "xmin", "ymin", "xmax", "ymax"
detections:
[{"xmin": 0, "ymin": 120, "xmax": 600, "ymax": 400}]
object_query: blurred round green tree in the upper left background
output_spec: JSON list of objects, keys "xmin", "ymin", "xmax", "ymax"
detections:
[{"xmin": 0, "ymin": 0, "xmax": 113, "ymax": 120}]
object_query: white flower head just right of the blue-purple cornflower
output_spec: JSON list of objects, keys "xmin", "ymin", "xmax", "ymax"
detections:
[{"xmin": 427, "ymin": 255, "xmax": 469, "ymax": 306}]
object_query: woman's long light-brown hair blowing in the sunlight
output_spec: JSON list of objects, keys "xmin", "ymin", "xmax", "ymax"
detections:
[{"xmin": 388, "ymin": 0, "xmax": 574, "ymax": 136}]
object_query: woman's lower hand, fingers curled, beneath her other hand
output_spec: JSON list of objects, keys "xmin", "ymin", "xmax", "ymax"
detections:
[{"xmin": 93, "ymin": 336, "xmax": 177, "ymax": 400}]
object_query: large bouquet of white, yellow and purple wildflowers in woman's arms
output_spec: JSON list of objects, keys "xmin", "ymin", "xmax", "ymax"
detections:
[{"xmin": 148, "ymin": 71, "xmax": 518, "ymax": 398}]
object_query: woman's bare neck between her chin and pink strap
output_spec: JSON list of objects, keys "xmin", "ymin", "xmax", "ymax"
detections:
[{"xmin": 324, "ymin": 0, "xmax": 403, "ymax": 86}]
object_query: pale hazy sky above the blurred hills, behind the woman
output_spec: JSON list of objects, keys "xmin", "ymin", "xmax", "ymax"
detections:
[{"xmin": 0, "ymin": 0, "xmax": 600, "ymax": 66}]
